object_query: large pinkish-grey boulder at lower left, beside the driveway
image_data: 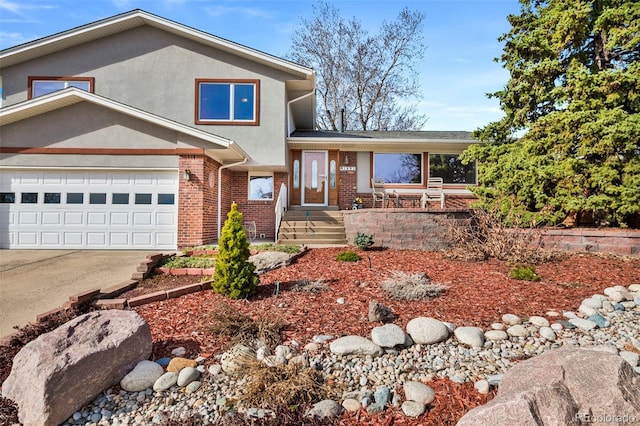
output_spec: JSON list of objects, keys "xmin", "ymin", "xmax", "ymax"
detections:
[{"xmin": 2, "ymin": 310, "xmax": 151, "ymax": 426}]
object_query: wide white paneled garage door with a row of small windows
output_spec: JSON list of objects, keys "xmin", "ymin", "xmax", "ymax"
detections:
[{"xmin": 0, "ymin": 170, "xmax": 178, "ymax": 250}]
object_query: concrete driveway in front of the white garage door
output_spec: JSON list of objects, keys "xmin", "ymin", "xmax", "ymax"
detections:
[{"xmin": 0, "ymin": 250, "xmax": 157, "ymax": 336}]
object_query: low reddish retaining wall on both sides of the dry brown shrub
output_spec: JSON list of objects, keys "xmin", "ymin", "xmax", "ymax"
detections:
[{"xmin": 343, "ymin": 208, "xmax": 640, "ymax": 257}]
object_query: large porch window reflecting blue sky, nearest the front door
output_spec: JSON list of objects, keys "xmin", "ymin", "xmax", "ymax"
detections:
[{"xmin": 373, "ymin": 152, "xmax": 424, "ymax": 185}]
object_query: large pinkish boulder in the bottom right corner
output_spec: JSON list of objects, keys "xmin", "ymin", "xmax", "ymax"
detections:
[{"xmin": 458, "ymin": 346, "xmax": 640, "ymax": 426}]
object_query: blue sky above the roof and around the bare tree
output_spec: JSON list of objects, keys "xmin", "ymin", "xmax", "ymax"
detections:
[{"xmin": 0, "ymin": 0, "xmax": 519, "ymax": 130}]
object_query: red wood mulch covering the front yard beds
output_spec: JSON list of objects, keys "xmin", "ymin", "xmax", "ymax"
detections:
[{"xmin": 126, "ymin": 248, "xmax": 640, "ymax": 425}]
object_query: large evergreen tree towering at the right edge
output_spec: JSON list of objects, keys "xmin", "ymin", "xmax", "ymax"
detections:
[{"xmin": 463, "ymin": 0, "xmax": 640, "ymax": 226}]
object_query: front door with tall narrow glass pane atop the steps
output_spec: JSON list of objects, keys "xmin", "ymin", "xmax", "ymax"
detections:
[{"xmin": 302, "ymin": 151, "xmax": 329, "ymax": 206}]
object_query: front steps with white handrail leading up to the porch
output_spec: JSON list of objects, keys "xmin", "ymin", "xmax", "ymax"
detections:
[{"xmin": 278, "ymin": 209, "xmax": 347, "ymax": 244}]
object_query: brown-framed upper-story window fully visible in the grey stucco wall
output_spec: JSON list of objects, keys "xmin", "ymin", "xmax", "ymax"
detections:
[{"xmin": 196, "ymin": 79, "xmax": 260, "ymax": 125}]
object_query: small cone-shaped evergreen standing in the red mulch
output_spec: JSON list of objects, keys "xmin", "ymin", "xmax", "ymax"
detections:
[{"xmin": 212, "ymin": 202, "xmax": 260, "ymax": 299}]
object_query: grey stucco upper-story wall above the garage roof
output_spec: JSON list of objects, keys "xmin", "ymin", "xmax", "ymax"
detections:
[{"xmin": 2, "ymin": 26, "xmax": 294, "ymax": 166}]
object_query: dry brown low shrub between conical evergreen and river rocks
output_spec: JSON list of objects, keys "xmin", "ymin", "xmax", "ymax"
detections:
[{"xmin": 208, "ymin": 303, "xmax": 287, "ymax": 348}]
